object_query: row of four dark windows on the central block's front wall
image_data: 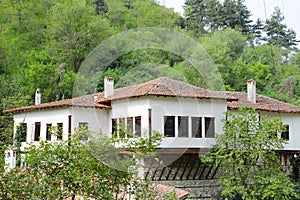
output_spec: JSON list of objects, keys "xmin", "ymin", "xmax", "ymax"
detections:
[{"xmin": 164, "ymin": 116, "xmax": 215, "ymax": 138}]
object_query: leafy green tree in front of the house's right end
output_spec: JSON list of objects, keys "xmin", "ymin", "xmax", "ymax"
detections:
[{"xmin": 202, "ymin": 107, "xmax": 297, "ymax": 200}]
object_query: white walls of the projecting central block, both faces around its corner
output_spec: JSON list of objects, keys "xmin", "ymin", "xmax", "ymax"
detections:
[{"xmin": 109, "ymin": 96, "xmax": 227, "ymax": 148}]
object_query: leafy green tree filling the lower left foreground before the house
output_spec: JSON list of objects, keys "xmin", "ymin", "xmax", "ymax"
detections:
[{"xmin": 0, "ymin": 129, "xmax": 161, "ymax": 199}]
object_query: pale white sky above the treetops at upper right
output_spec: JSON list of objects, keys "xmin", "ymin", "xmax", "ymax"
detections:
[{"xmin": 158, "ymin": 0, "xmax": 300, "ymax": 40}]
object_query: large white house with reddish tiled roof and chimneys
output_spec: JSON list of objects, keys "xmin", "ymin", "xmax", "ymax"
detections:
[{"xmin": 2, "ymin": 77, "xmax": 300, "ymax": 175}]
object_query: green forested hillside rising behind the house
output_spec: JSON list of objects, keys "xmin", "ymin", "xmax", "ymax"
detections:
[{"xmin": 0, "ymin": 0, "xmax": 300, "ymax": 147}]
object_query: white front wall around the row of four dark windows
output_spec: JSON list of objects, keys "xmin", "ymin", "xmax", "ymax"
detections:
[{"xmin": 150, "ymin": 97, "xmax": 227, "ymax": 148}]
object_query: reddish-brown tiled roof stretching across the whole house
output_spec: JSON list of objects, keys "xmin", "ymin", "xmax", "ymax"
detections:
[{"xmin": 5, "ymin": 77, "xmax": 300, "ymax": 113}]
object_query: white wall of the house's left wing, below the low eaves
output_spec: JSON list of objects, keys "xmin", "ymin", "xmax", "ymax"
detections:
[{"xmin": 14, "ymin": 107, "xmax": 108, "ymax": 145}]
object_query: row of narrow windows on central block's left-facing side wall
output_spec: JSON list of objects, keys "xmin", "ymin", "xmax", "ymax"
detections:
[{"xmin": 111, "ymin": 116, "xmax": 142, "ymax": 138}]
